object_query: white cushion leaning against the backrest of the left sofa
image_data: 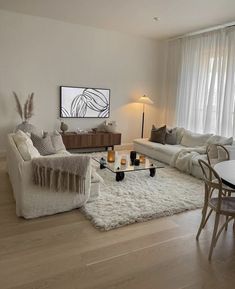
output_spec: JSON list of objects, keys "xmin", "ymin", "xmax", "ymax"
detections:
[{"xmin": 13, "ymin": 130, "xmax": 40, "ymax": 161}]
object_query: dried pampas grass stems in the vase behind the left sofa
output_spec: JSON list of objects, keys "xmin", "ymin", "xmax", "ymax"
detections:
[{"xmin": 13, "ymin": 91, "xmax": 34, "ymax": 121}]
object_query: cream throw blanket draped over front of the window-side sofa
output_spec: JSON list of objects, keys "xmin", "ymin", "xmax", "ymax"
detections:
[{"xmin": 170, "ymin": 147, "xmax": 206, "ymax": 174}]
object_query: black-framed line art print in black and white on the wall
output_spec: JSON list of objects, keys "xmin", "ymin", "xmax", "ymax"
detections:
[{"xmin": 60, "ymin": 86, "xmax": 110, "ymax": 118}]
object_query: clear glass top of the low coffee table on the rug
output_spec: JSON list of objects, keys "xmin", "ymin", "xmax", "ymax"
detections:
[{"xmin": 93, "ymin": 151, "xmax": 164, "ymax": 173}]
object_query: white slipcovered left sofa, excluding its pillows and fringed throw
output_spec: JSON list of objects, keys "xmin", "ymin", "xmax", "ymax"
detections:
[{"xmin": 7, "ymin": 134, "xmax": 102, "ymax": 219}]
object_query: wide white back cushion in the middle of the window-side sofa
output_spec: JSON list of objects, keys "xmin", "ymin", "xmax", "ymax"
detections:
[{"xmin": 181, "ymin": 130, "xmax": 212, "ymax": 147}]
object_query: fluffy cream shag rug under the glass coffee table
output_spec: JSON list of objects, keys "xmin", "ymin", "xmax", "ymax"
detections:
[{"xmin": 81, "ymin": 152, "xmax": 204, "ymax": 231}]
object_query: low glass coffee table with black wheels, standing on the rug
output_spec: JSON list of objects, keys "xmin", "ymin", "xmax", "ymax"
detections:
[{"xmin": 93, "ymin": 151, "xmax": 164, "ymax": 182}]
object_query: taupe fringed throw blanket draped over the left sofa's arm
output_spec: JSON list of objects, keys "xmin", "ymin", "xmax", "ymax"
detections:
[{"xmin": 32, "ymin": 155, "xmax": 91, "ymax": 194}]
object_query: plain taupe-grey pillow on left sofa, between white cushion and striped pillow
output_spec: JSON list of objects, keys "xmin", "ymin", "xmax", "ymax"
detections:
[{"xmin": 31, "ymin": 133, "xmax": 56, "ymax": 156}]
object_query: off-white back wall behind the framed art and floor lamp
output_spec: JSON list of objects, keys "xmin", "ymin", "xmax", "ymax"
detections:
[{"xmin": 0, "ymin": 10, "xmax": 162, "ymax": 151}]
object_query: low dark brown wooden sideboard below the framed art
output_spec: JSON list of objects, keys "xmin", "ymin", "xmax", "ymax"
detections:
[{"xmin": 61, "ymin": 132, "xmax": 121, "ymax": 150}]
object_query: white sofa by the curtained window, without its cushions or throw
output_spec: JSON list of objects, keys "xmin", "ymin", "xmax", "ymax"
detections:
[{"xmin": 133, "ymin": 129, "xmax": 235, "ymax": 178}]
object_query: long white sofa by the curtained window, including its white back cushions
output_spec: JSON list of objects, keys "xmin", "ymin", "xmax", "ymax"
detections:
[{"xmin": 133, "ymin": 128, "xmax": 235, "ymax": 178}]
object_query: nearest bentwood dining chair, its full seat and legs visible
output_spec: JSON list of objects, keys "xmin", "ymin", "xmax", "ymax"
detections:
[{"xmin": 196, "ymin": 159, "xmax": 235, "ymax": 260}]
